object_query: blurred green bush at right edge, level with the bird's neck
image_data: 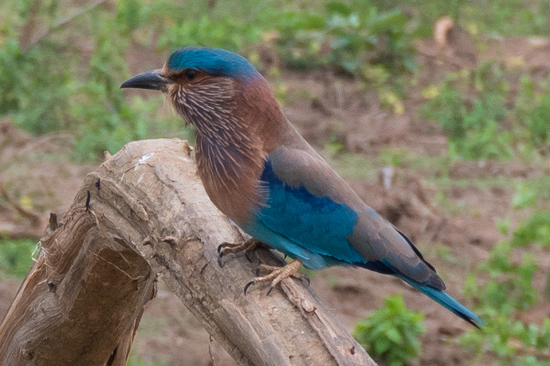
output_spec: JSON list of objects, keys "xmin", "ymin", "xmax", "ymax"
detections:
[{"xmin": 422, "ymin": 62, "xmax": 550, "ymax": 160}]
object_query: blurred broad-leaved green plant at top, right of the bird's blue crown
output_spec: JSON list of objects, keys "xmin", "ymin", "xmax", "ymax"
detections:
[{"xmin": 269, "ymin": 1, "xmax": 416, "ymax": 76}]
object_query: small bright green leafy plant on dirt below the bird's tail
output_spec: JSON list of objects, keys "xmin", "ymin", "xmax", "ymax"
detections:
[{"xmin": 353, "ymin": 294, "xmax": 426, "ymax": 366}]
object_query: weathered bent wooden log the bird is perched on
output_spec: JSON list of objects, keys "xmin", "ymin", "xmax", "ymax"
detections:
[{"xmin": 0, "ymin": 140, "xmax": 375, "ymax": 366}]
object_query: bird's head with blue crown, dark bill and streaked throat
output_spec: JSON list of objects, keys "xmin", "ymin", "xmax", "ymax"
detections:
[{"xmin": 121, "ymin": 47, "xmax": 276, "ymax": 135}]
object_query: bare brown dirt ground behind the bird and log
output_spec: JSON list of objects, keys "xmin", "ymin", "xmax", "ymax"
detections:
[{"xmin": 0, "ymin": 38, "xmax": 550, "ymax": 366}]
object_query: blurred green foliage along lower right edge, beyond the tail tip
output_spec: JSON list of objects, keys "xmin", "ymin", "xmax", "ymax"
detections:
[{"xmin": 460, "ymin": 155, "xmax": 550, "ymax": 366}]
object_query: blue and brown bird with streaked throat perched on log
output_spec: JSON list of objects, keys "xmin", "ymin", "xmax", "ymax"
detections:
[{"xmin": 121, "ymin": 46, "xmax": 485, "ymax": 328}]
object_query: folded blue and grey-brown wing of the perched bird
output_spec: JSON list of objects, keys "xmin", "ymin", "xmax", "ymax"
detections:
[{"xmin": 257, "ymin": 147, "xmax": 444, "ymax": 289}]
